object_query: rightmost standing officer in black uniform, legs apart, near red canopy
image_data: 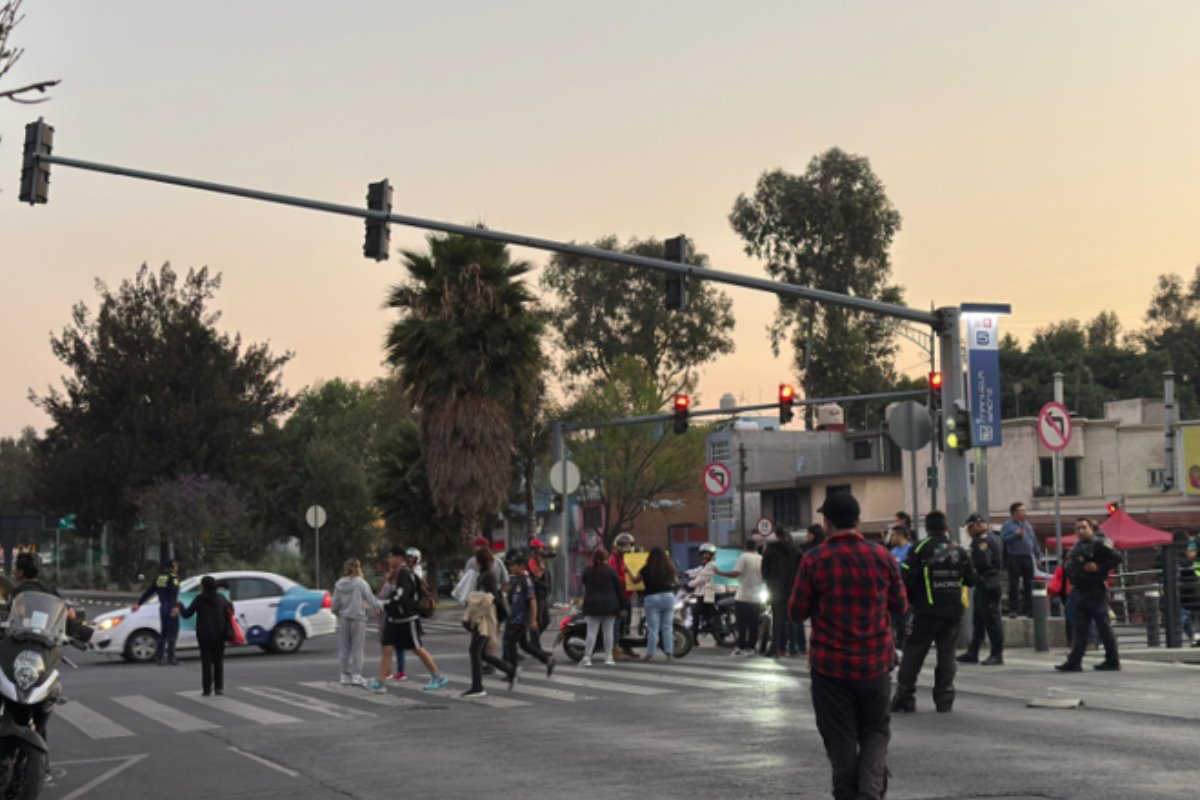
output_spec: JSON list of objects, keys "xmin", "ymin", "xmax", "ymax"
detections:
[{"xmin": 1055, "ymin": 517, "xmax": 1124, "ymax": 672}]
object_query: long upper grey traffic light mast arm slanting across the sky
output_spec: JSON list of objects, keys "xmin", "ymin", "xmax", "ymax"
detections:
[{"xmin": 38, "ymin": 149, "xmax": 938, "ymax": 326}]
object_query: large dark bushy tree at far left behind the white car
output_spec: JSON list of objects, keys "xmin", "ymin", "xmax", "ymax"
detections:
[{"xmin": 31, "ymin": 265, "xmax": 293, "ymax": 583}]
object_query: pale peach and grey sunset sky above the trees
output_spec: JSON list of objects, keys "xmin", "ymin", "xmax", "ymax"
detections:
[{"xmin": 0, "ymin": 0, "xmax": 1200, "ymax": 435}]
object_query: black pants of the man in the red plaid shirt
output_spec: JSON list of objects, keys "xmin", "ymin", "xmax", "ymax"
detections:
[{"xmin": 811, "ymin": 672, "xmax": 892, "ymax": 800}]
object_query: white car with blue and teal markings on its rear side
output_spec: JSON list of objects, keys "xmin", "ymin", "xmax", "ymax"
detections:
[{"xmin": 88, "ymin": 572, "xmax": 337, "ymax": 662}]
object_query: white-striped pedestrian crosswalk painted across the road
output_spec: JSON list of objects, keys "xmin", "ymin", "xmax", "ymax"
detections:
[{"xmin": 54, "ymin": 656, "xmax": 806, "ymax": 740}]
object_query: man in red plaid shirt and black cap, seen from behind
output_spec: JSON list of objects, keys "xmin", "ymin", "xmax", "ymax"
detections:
[{"xmin": 788, "ymin": 492, "xmax": 908, "ymax": 800}]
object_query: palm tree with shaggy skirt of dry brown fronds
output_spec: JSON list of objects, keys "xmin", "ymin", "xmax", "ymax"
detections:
[{"xmin": 386, "ymin": 235, "xmax": 542, "ymax": 536}]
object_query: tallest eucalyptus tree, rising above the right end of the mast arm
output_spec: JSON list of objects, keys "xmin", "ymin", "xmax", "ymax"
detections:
[{"xmin": 730, "ymin": 148, "xmax": 902, "ymax": 427}]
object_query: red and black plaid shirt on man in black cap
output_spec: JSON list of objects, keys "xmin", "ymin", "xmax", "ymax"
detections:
[{"xmin": 788, "ymin": 530, "xmax": 908, "ymax": 680}]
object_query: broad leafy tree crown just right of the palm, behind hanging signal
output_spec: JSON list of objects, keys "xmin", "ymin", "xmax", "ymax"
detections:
[{"xmin": 541, "ymin": 236, "xmax": 733, "ymax": 401}]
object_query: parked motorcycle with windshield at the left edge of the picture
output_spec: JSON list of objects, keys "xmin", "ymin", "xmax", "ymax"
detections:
[{"xmin": 0, "ymin": 591, "xmax": 91, "ymax": 800}]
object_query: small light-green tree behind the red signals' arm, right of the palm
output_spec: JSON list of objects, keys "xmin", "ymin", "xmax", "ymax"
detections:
[{"xmin": 569, "ymin": 357, "xmax": 704, "ymax": 542}]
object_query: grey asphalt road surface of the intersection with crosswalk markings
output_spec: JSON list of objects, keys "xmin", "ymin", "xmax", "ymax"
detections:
[{"xmin": 43, "ymin": 606, "xmax": 1200, "ymax": 800}]
